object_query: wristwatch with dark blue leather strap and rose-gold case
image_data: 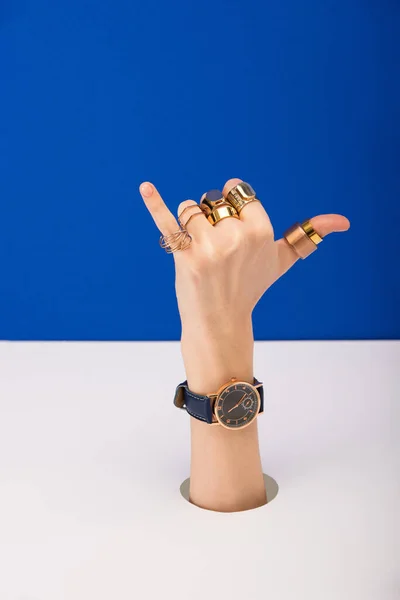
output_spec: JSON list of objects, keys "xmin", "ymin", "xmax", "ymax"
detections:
[{"xmin": 174, "ymin": 377, "xmax": 264, "ymax": 429}]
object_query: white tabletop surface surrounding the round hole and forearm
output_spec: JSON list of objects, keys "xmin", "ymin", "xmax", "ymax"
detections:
[{"xmin": 0, "ymin": 342, "xmax": 400, "ymax": 600}]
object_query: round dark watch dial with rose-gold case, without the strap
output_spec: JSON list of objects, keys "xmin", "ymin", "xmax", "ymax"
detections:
[{"xmin": 214, "ymin": 381, "xmax": 260, "ymax": 429}]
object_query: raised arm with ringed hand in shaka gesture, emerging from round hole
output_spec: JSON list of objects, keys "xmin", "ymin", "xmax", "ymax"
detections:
[{"xmin": 140, "ymin": 178, "xmax": 350, "ymax": 511}]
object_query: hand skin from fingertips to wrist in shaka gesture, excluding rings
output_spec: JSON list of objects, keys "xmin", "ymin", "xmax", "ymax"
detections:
[{"xmin": 140, "ymin": 179, "xmax": 350, "ymax": 340}]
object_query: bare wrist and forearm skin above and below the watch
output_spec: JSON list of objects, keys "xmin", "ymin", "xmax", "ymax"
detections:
[{"xmin": 182, "ymin": 318, "xmax": 266, "ymax": 512}]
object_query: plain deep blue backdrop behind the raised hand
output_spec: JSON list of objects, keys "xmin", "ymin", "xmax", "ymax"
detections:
[{"xmin": 0, "ymin": 0, "xmax": 400, "ymax": 340}]
